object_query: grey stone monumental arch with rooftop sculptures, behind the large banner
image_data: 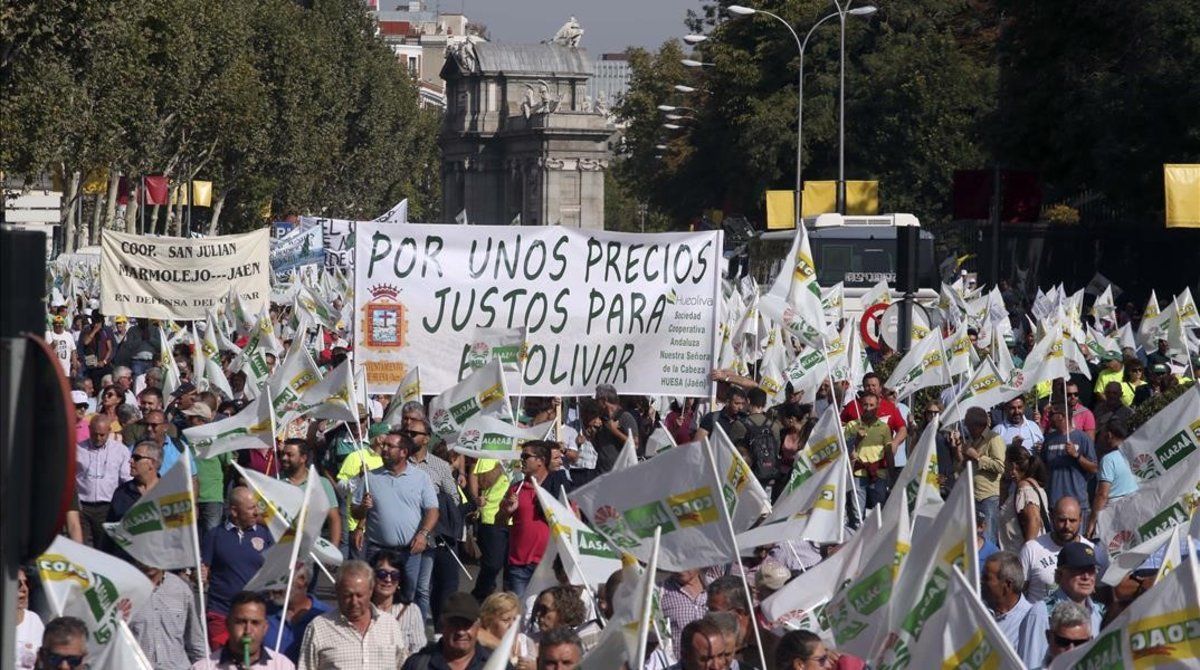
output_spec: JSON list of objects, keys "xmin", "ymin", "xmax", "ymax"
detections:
[{"xmin": 438, "ymin": 17, "xmax": 616, "ymax": 228}]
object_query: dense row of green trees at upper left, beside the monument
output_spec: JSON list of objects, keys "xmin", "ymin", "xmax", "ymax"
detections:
[{"xmin": 0, "ymin": 0, "xmax": 440, "ymax": 240}]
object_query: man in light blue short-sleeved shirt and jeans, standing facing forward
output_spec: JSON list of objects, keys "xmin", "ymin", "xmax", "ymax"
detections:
[{"xmin": 352, "ymin": 430, "xmax": 438, "ymax": 621}]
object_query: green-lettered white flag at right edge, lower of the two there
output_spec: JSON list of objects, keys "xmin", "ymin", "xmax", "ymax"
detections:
[{"xmin": 1096, "ymin": 455, "xmax": 1200, "ymax": 558}]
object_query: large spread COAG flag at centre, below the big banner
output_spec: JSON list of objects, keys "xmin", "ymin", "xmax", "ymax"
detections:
[{"xmin": 570, "ymin": 442, "xmax": 737, "ymax": 572}]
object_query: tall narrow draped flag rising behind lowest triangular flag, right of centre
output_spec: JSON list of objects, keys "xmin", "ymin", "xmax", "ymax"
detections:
[{"xmin": 872, "ymin": 466, "xmax": 979, "ymax": 670}]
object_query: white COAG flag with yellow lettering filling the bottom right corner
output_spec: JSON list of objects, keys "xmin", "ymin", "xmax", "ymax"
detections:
[{"xmin": 1050, "ymin": 545, "xmax": 1200, "ymax": 670}]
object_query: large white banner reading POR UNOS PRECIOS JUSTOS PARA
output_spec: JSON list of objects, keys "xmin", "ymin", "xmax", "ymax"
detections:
[{"xmin": 354, "ymin": 222, "xmax": 721, "ymax": 397}]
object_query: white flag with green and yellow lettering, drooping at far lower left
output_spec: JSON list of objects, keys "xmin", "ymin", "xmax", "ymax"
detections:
[{"xmin": 37, "ymin": 536, "xmax": 154, "ymax": 658}]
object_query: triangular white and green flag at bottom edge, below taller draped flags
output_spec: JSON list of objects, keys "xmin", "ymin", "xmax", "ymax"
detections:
[{"xmin": 907, "ymin": 569, "xmax": 1022, "ymax": 670}]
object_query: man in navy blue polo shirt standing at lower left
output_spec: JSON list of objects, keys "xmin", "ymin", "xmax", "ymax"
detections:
[{"xmin": 200, "ymin": 486, "xmax": 275, "ymax": 650}]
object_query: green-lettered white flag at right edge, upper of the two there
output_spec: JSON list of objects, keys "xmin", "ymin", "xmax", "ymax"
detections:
[{"xmin": 1121, "ymin": 384, "xmax": 1200, "ymax": 480}]
